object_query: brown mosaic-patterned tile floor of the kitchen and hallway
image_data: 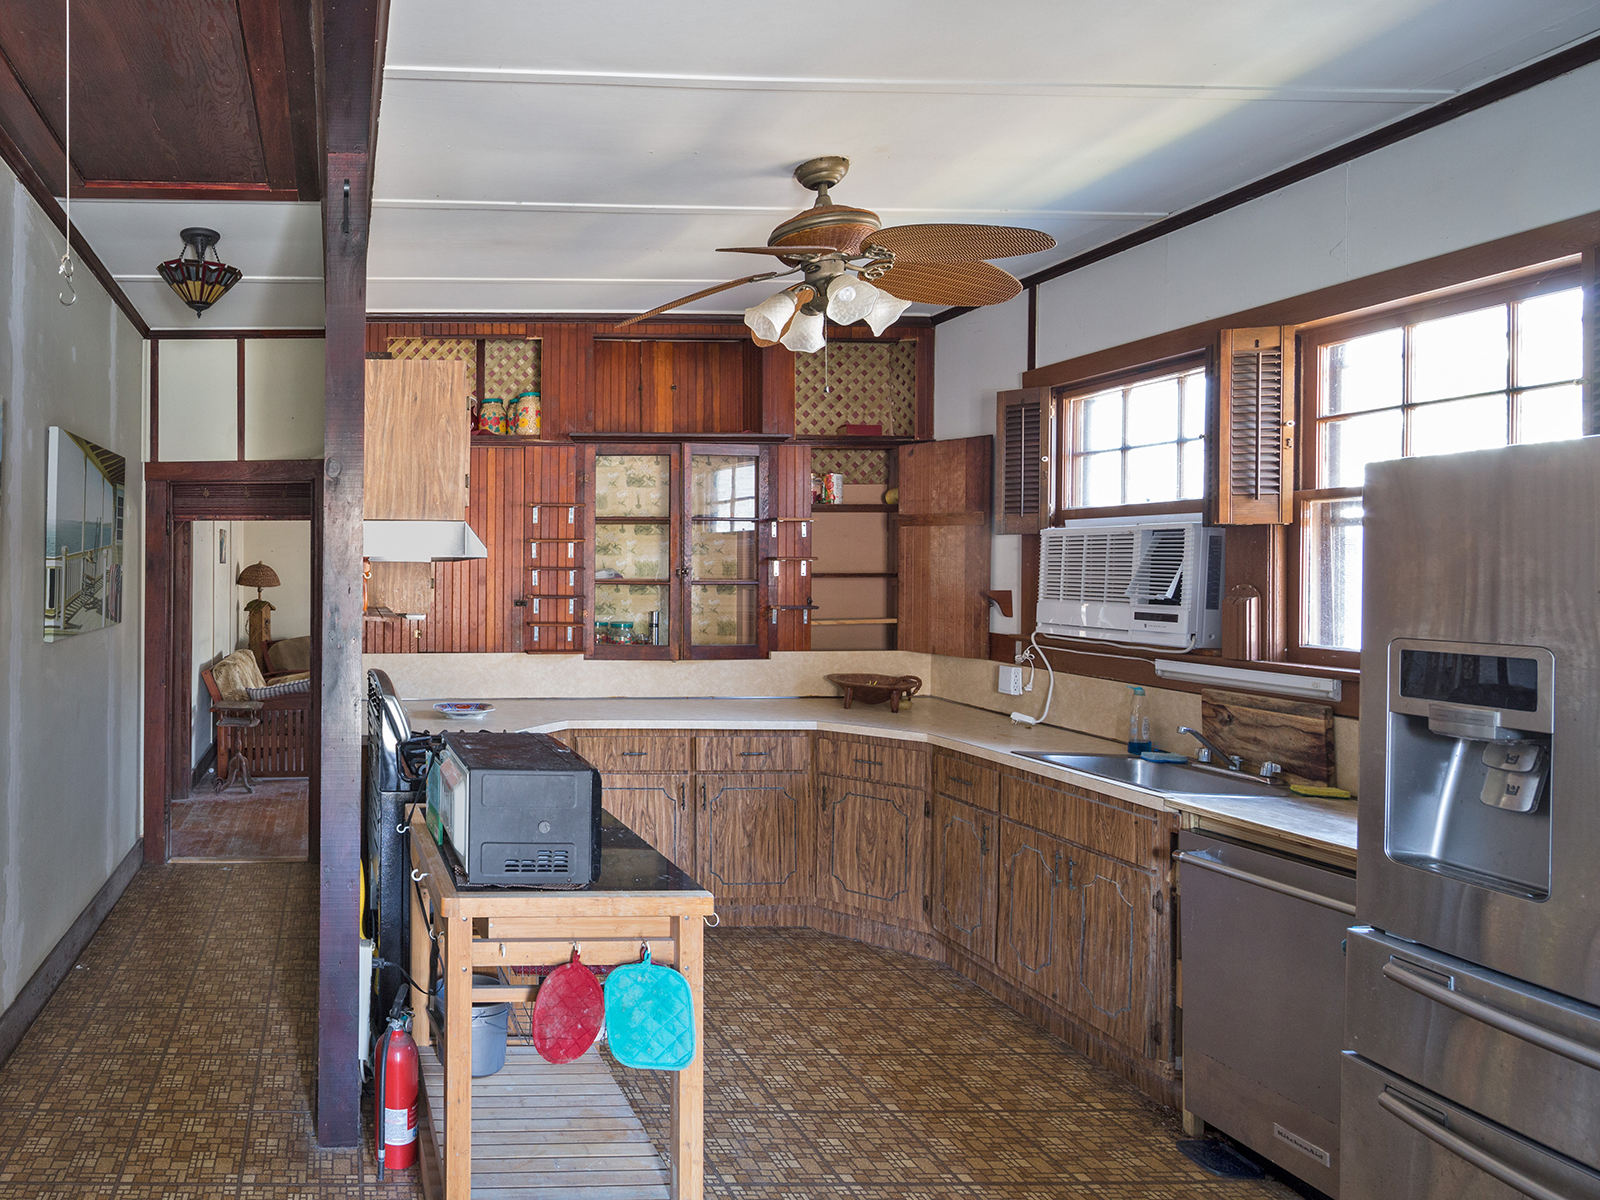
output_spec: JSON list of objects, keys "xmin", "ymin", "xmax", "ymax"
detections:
[{"xmin": 0, "ymin": 862, "xmax": 1293, "ymax": 1200}]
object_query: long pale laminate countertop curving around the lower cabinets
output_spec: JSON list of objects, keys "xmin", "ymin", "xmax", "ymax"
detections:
[{"xmin": 403, "ymin": 696, "xmax": 1355, "ymax": 869}]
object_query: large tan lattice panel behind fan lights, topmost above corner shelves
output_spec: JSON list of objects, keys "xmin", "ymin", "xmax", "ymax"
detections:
[{"xmin": 795, "ymin": 341, "xmax": 917, "ymax": 438}]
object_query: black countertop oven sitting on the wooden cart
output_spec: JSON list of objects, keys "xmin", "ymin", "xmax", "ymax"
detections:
[{"xmin": 427, "ymin": 733, "xmax": 600, "ymax": 888}]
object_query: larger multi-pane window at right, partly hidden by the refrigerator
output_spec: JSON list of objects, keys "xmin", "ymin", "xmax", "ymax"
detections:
[{"xmin": 1296, "ymin": 274, "xmax": 1584, "ymax": 653}]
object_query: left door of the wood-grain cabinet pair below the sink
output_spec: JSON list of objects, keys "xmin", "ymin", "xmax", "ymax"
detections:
[{"xmin": 995, "ymin": 819, "xmax": 1070, "ymax": 1000}]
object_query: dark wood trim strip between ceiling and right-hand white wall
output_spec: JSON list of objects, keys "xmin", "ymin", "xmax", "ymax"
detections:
[{"xmin": 933, "ymin": 35, "xmax": 1600, "ymax": 329}]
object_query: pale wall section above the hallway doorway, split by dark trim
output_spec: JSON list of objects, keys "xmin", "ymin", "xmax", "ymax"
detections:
[{"xmin": 155, "ymin": 338, "xmax": 323, "ymax": 462}]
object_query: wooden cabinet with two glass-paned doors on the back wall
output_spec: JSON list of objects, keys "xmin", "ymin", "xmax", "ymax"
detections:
[{"xmin": 589, "ymin": 443, "xmax": 766, "ymax": 659}]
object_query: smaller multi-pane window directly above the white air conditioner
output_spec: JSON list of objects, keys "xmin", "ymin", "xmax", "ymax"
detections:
[{"xmin": 1061, "ymin": 365, "xmax": 1206, "ymax": 509}]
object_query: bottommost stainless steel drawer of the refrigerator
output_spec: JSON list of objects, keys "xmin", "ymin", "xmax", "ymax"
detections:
[{"xmin": 1341, "ymin": 1054, "xmax": 1600, "ymax": 1200}]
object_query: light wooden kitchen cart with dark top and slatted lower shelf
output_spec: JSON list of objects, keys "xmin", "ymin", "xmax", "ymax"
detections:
[{"xmin": 410, "ymin": 808, "xmax": 714, "ymax": 1200}]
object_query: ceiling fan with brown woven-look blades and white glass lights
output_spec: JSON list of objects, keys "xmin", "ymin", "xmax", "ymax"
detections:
[{"xmin": 618, "ymin": 155, "xmax": 1056, "ymax": 354}]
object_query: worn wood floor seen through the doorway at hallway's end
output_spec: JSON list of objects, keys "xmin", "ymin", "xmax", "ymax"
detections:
[{"xmin": 168, "ymin": 774, "xmax": 309, "ymax": 862}]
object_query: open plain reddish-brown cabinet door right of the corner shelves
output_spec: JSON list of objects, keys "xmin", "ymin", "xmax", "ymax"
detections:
[{"xmin": 896, "ymin": 437, "xmax": 994, "ymax": 658}]
